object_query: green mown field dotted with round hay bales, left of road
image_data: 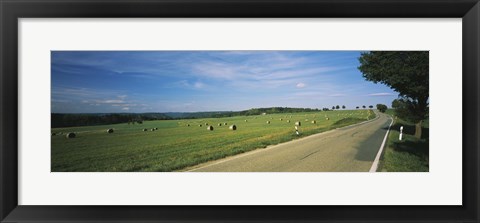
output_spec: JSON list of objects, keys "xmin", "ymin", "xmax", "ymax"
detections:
[{"xmin": 51, "ymin": 110, "xmax": 375, "ymax": 172}]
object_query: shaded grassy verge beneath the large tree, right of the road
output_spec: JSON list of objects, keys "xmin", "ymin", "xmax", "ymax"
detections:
[{"xmin": 379, "ymin": 109, "xmax": 429, "ymax": 172}]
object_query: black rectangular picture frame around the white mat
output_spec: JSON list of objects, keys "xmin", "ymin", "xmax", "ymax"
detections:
[{"xmin": 0, "ymin": 0, "xmax": 480, "ymax": 222}]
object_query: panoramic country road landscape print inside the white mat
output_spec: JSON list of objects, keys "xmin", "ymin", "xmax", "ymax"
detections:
[{"xmin": 51, "ymin": 50, "xmax": 429, "ymax": 172}]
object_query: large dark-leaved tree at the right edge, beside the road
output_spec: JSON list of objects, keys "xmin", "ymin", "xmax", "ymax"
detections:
[{"xmin": 358, "ymin": 51, "xmax": 429, "ymax": 138}]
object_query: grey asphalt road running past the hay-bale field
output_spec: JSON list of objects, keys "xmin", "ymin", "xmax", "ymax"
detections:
[{"xmin": 188, "ymin": 113, "xmax": 391, "ymax": 172}]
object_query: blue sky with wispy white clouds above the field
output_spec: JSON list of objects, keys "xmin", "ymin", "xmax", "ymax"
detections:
[{"xmin": 51, "ymin": 51, "xmax": 398, "ymax": 113}]
